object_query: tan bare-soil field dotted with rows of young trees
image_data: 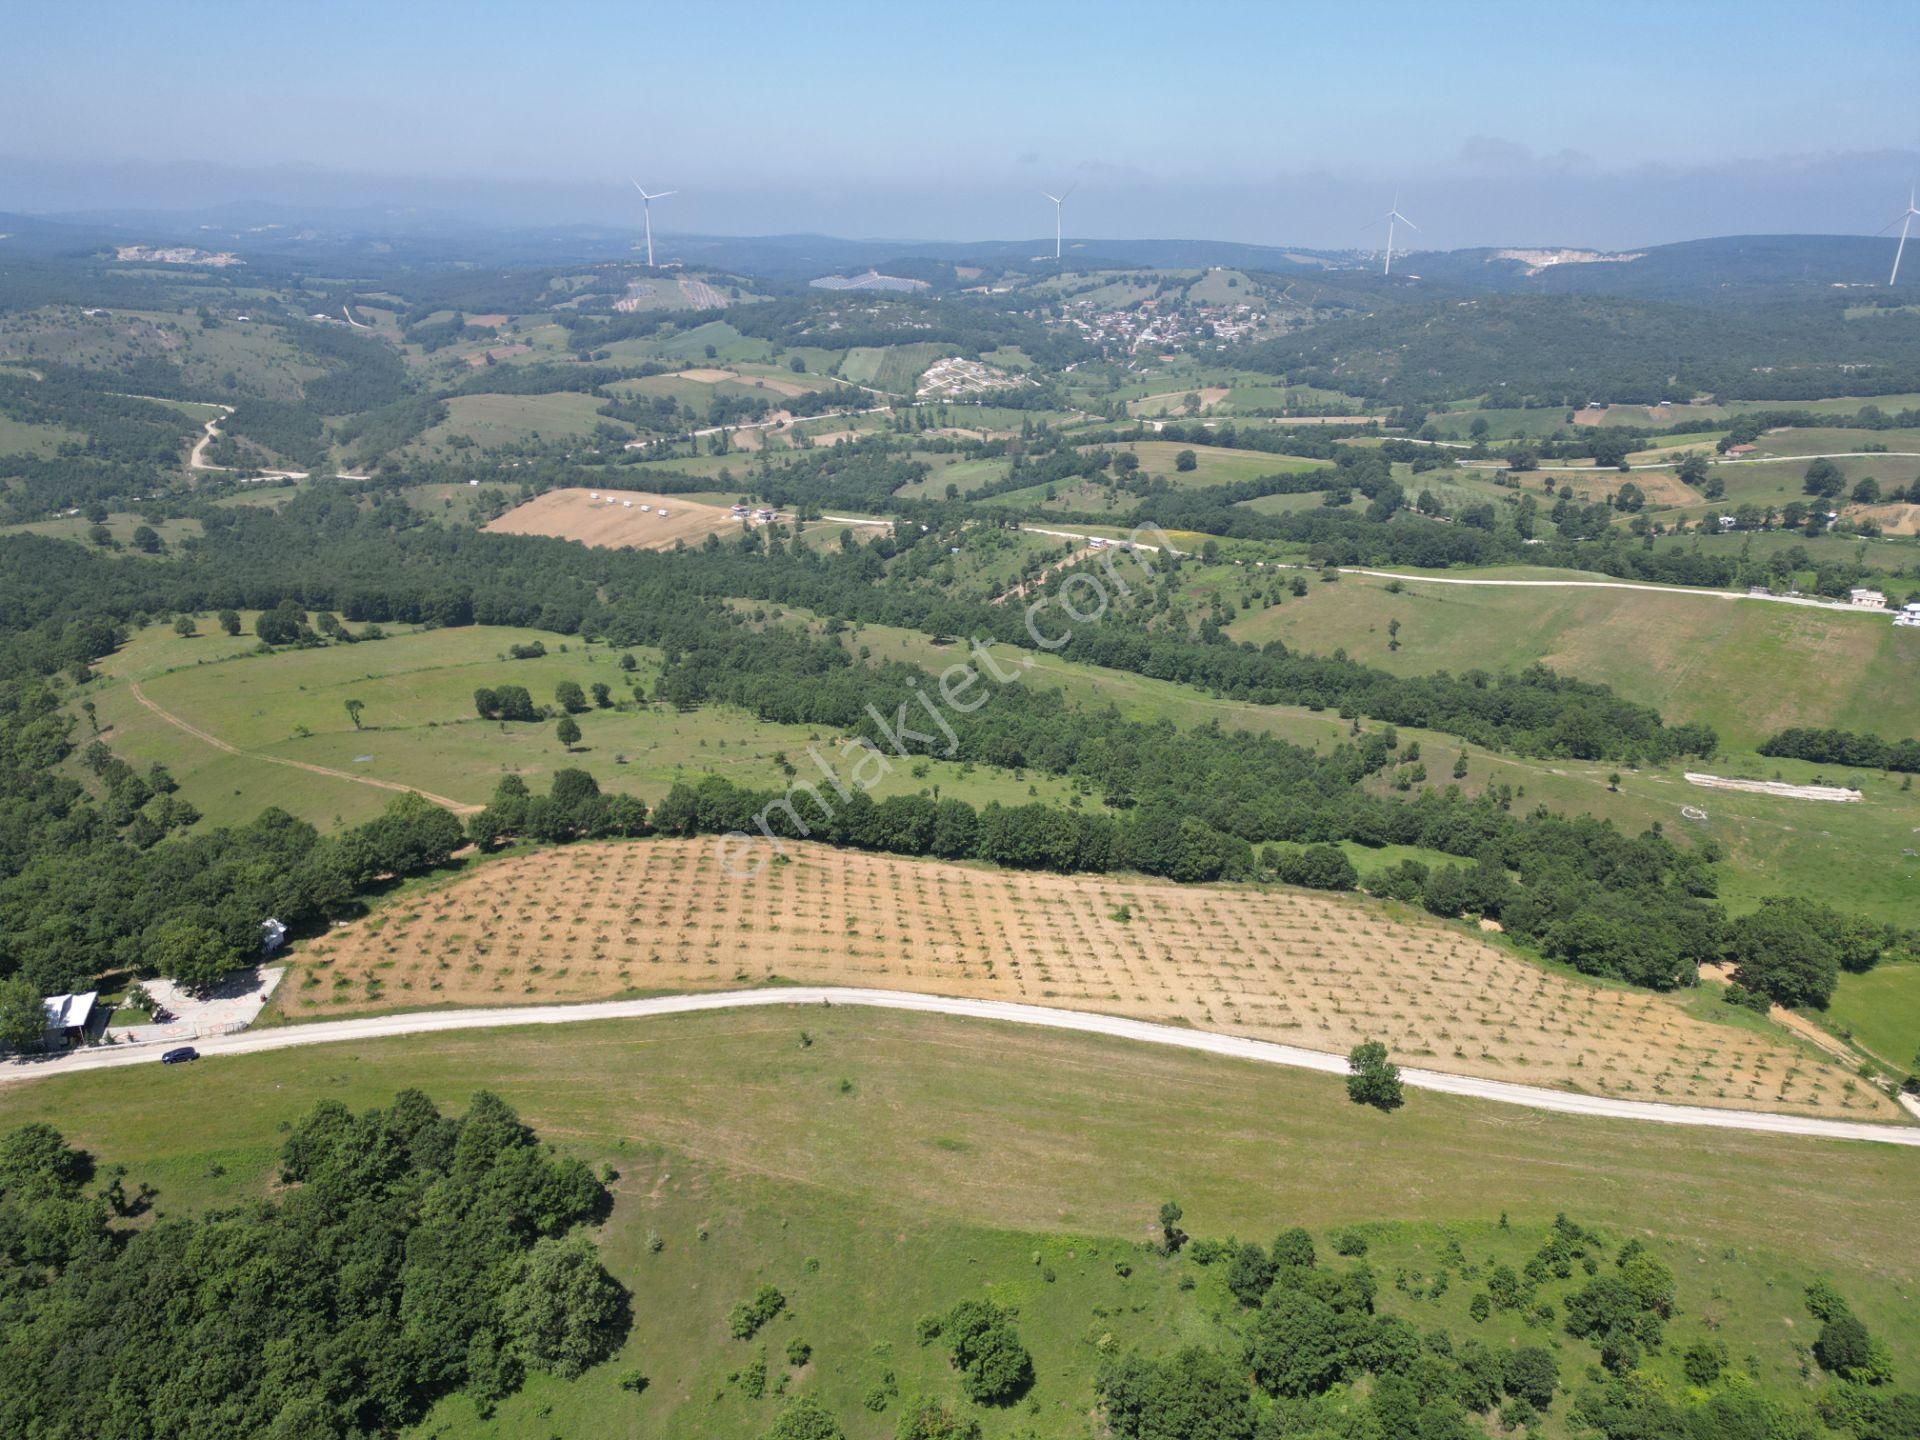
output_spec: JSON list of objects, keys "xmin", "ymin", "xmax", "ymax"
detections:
[{"xmin": 278, "ymin": 839, "xmax": 1897, "ymax": 1119}]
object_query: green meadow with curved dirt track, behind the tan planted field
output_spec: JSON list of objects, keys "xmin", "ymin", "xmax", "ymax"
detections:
[{"xmin": 81, "ymin": 622, "xmax": 1068, "ymax": 829}]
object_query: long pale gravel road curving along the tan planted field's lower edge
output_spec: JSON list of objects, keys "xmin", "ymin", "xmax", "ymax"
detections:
[{"xmin": 15, "ymin": 985, "xmax": 1920, "ymax": 1146}]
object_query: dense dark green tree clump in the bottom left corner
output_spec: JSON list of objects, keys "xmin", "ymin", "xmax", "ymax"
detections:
[{"xmin": 0, "ymin": 1091, "xmax": 630, "ymax": 1440}]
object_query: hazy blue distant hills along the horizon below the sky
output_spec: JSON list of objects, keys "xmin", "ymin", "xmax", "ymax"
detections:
[{"xmin": 0, "ymin": 205, "xmax": 1920, "ymax": 300}]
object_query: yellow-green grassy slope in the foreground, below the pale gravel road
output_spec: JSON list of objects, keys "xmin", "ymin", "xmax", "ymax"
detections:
[{"xmin": 0, "ymin": 1008, "xmax": 1920, "ymax": 1440}]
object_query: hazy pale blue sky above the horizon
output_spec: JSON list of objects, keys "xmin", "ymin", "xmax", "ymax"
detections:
[{"xmin": 0, "ymin": 0, "xmax": 1920, "ymax": 246}]
